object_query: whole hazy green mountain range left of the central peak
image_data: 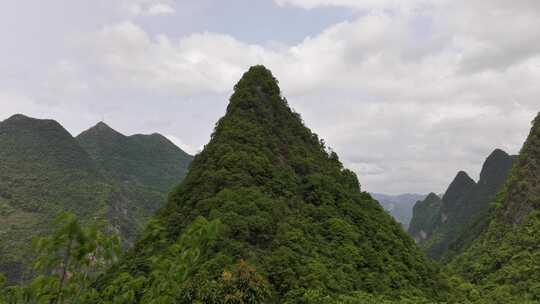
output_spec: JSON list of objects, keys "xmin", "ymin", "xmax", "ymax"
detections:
[{"xmin": 0, "ymin": 114, "xmax": 192, "ymax": 282}]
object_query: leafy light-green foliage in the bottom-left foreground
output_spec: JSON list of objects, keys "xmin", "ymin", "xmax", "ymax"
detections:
[{"xmin": 0, "ymin": 213, "xmax": 120, "ymax": 304}]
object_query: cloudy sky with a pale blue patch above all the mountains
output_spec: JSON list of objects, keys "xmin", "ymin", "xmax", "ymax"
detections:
[{"xmin": 0, "ymin": 0, "xmax": 540, "ymax": 194}]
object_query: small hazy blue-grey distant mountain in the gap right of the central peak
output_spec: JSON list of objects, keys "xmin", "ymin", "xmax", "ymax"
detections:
[{"xmin": 371, "ymin": 193, "xmax": 426, "ymax": 230}]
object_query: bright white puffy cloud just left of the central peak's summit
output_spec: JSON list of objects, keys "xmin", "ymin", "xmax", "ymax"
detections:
[{"xmin": 73, "ymin": 21, "xmax": 267, "ymax": 95}]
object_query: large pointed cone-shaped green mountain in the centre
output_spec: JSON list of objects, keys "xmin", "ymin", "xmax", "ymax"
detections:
[{"xmin": 104, "ymin": 66, "xmax": 445, "ymax": 303}]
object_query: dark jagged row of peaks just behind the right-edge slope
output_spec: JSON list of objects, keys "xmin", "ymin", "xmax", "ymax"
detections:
[{"xmin": 409, "ymin": 149, "xmax": 514, "ymax": 259}]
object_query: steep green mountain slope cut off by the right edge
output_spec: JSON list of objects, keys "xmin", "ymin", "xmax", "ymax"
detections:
[{"xmin": 451, "ymin": 114, "xmax": 540, "ymax": 303}]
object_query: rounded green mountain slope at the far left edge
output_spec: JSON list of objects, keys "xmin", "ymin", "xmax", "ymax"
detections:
[{"xmin": 0, "ymin": 115, "xmax": 114, "ymax": 281}]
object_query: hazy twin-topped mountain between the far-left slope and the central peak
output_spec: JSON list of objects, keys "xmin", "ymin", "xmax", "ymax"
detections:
[{"xmin": 76, "ymin": 122, "xmax": 193, "ymax": 224}]
